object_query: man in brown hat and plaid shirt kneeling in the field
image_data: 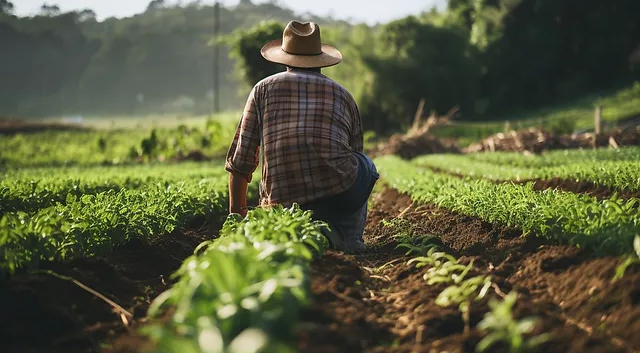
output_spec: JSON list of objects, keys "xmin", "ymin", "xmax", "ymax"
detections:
[{"xmin": 225, "ymin": 21, "xmax": 378, "ymax": 252}]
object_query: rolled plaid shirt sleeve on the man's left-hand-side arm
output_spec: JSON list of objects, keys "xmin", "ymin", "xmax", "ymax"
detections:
[{"xmin": 225, "ymin": 87, "xmax": 261, "ymax": 181}]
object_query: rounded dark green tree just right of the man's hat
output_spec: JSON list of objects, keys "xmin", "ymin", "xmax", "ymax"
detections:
[{"xmin": 361, "ymin": 17, "xmax": 480, "ymax": 130}]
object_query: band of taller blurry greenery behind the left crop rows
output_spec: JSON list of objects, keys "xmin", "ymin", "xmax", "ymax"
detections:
[{"xmin": 0, "ymin": 116, "xmax": 237, "ymax": 171}]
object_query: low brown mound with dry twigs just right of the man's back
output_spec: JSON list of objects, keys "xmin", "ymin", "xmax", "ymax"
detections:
[{"xmin": 370, "ymin": 133, "xmax": 460, "ymax": 159}]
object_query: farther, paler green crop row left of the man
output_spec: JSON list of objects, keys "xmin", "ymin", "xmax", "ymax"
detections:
[{"xmin": 0, "ymin": 163, "xmax": 232, "ymax": 213}]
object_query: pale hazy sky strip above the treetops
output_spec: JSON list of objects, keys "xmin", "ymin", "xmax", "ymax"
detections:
[{"xmin": 11, "ymin": 0, "xmax": 446, "ymax": 24}]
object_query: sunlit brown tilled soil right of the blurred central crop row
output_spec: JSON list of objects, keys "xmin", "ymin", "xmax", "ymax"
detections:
[{"xmin": 298, "ymin": 190, "xmax": 640, "ymax": 352}]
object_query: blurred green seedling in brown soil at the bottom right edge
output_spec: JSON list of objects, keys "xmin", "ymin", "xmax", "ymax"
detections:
[{"xmin": 476, "ymin": 292, "xmax": 551, "ymax": 353}]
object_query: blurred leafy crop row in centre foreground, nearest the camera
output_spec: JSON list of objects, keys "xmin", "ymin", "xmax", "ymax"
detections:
[{"xmin": 143, "ymin": 205, "xmax": 328, "ymax": 353}]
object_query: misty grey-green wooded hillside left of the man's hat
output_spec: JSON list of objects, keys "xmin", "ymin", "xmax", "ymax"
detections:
[{"xmin": 0, "ymin": 0, "xmax": 344, "ymax": 116}]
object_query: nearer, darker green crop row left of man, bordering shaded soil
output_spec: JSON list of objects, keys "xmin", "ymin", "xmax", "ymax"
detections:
[{"xmin": 0, "ymin": 176, "xmax": 238, "ymax": 272}]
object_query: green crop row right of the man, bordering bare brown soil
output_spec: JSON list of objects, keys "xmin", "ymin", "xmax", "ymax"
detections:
[{"xmin": 376, "ymin": 156, "xmax": 640, "ymax": 254}]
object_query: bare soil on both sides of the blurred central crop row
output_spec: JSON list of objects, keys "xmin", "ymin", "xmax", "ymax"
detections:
[{"xmin": 0, "ymin": 189, "xmax": 640, "ymax": 353}]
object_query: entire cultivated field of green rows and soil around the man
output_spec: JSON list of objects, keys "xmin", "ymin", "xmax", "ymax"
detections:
[{"xmin": 0, "ymin": 123, "xmax": 640, "ymax": 352}]
